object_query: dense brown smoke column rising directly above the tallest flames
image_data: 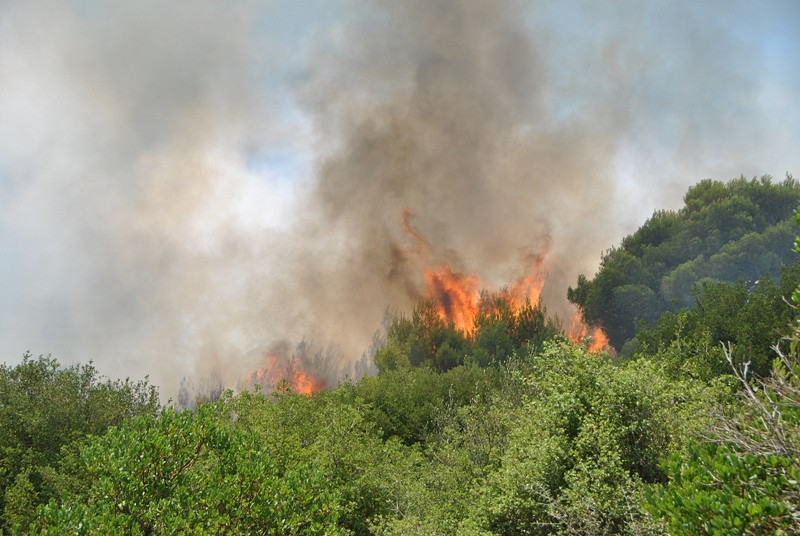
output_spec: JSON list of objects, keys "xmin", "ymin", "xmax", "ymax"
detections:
[{"xmin": 294, "ymin": 2, "xmax": 620, "ymax": 356}]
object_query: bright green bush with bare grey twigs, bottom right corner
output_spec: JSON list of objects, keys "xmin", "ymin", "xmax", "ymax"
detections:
[{"xmin": 648, "ymin": 306, "xmax": 800, "ymax": 534}]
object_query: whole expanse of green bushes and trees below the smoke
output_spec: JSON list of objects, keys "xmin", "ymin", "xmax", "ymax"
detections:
[{"xmin": 0, "ymin": 179, "xmax": 800, "ymax": 535}]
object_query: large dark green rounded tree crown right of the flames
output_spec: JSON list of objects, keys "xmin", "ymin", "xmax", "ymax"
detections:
[{"xmin": 568, "ymin": 176, "xmax": 800, "ymax": 348}]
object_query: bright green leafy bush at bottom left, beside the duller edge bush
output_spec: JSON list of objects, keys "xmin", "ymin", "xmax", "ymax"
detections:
[{"xmin": 33, "ymin": 403, "xmax": 338, "ymax": 534}]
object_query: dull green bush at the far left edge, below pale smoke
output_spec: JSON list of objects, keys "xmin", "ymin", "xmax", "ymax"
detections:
[{"xmin": 0, "ymin": 354, "xmax": 158, "ymax": 530}]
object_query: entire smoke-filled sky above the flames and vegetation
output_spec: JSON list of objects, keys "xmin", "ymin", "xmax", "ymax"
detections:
[{"xmin": 0, "ymin": 0, "xmax": 800, "ymax": 396}]
